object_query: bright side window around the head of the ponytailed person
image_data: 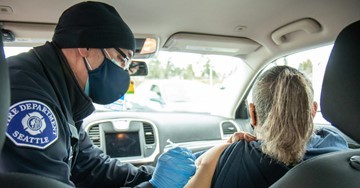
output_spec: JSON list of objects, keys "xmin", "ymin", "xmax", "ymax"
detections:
[{"xmin": 248, "ymin": 45, "xmax": 333, "ymax": 124}]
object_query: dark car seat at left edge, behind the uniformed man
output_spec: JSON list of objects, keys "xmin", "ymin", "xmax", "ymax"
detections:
[{"xmin": 0, "ymin": 31, "xmax": 70, "ymax": 188}]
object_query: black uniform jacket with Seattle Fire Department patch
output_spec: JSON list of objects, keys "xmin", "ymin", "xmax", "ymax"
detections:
[{"xmin": 1, "ymin": 43, "xmax": 153, "ymax": 187}]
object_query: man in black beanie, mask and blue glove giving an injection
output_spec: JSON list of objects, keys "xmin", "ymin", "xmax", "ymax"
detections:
[{"xmin": 0, "ymin": 1, "xmax": 196, "ymax": 188}]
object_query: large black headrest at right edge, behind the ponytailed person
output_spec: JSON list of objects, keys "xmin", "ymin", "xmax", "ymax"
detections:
[{"xmin": 320, "ymin": 21, "xmax": 360, "ymax": 142}]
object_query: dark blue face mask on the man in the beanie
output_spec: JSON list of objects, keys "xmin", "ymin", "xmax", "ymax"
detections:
[{"xmin": 84, "ymin": 51, "xmax": 130, "ymax": 104}]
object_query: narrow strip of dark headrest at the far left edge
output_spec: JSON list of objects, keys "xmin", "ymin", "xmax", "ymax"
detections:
[{"xmin": 0, "ymin": 30, "xmax": 10, "ymax": 152}]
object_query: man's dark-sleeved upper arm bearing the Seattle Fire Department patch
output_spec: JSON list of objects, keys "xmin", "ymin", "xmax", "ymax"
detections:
[{"xmin": 1, "ymin": 91, "xmax": 72, "ymax": 185}]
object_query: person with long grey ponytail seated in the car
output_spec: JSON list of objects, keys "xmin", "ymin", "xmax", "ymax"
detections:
[{"xmin": 185, "ymin": 66, "xmax": 348, "ymax": 188}]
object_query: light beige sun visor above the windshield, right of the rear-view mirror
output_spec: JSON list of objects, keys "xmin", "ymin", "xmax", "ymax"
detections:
[{"xmin": 164, "ymin": 33, "xmax": 260, "ymax": 56}]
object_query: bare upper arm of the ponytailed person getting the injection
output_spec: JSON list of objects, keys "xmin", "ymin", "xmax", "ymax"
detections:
[{"xmin": 185, "ymin": 143, "xmax": 230, "ymax": 188}]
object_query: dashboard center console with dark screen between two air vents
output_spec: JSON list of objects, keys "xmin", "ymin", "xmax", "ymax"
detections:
[{"xmin": 85, "ymin": 119, "xmax": 160, "ymax": 164}]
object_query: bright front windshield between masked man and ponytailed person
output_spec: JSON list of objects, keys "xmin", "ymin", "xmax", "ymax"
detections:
[{"xmin": 4, "ymin": 47, "xmax": 249, "ymax": 113}]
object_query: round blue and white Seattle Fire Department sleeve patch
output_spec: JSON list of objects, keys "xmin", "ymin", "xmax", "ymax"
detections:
[{"xmin": 6, "ymin": 100, "xmax": 58, "ymax": 149}]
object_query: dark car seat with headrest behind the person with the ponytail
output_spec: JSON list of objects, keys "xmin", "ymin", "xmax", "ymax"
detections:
[{"xmin": 271, "ymin": 21, "xmax": 360, "ymax": 188}]
